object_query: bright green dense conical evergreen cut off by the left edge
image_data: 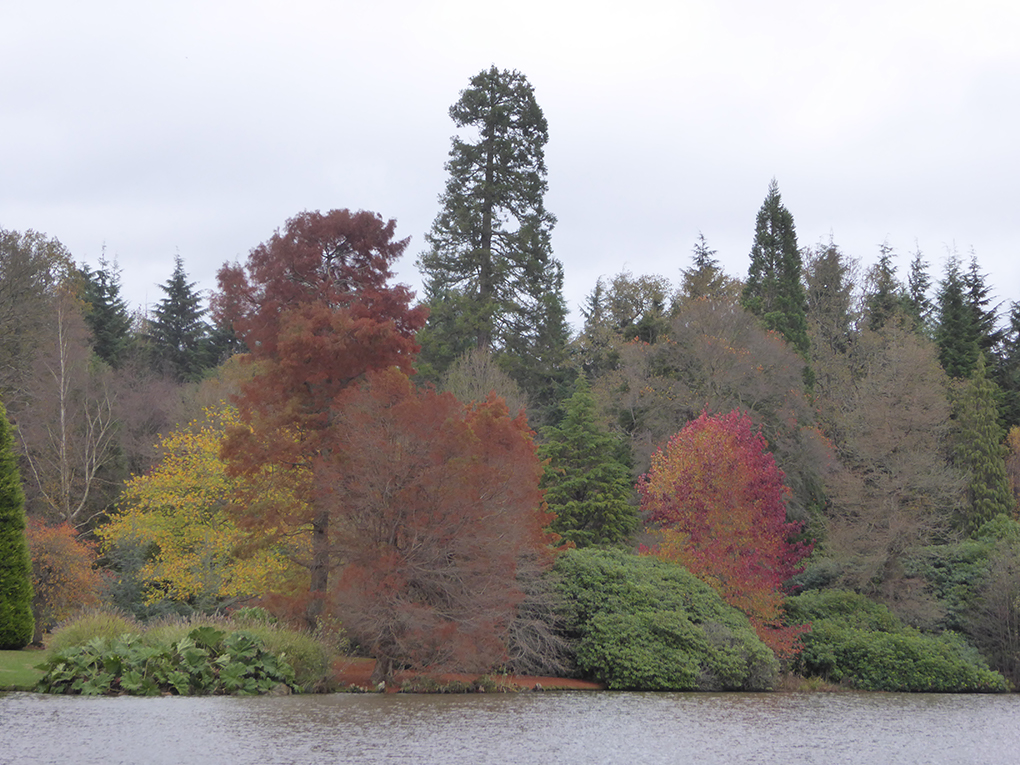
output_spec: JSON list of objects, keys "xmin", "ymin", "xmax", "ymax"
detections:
[{"xmin": 0, "ymin": 403, "xmax": 36, "ymax": 651}]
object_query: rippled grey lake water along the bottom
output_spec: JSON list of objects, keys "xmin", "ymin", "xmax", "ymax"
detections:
[{"xmin": 0, "ymin": 693, "xmax": 1020, "ymax": 765}]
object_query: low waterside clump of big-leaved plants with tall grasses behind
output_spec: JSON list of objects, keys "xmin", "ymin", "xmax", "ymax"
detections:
[{"xmin": 39, "ymin": 612, "xmax": 335, "ymax": 696}]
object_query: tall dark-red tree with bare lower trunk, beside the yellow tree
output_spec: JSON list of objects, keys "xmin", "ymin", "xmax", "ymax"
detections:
[{"xmin": 212, "ymin": 210, "xmax": 427, "ymax": 621}]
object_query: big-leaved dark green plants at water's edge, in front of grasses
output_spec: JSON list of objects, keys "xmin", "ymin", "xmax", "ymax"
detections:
[{"xmin": 37, "ymin": 625, "xmax": 297, "ymax": 696}]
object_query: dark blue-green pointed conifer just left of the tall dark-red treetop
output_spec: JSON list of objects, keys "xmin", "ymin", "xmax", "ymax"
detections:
[{"xmin": 149, "ymin": 255, "xmax": 211, "ymax": 383}]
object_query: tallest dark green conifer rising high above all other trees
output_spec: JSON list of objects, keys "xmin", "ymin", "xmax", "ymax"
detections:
[{"xmin": 418, "ymin": 66, "xmax": 568, "ymax": 410}]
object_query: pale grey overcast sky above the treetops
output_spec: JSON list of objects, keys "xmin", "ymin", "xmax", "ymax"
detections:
[{"xmin": 0, "ymin": 0, "xmax": 1020, "ymax": 323}]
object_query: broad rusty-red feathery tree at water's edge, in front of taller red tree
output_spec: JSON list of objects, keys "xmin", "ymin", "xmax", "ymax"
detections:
[{"xmin": 322, "ymin": 369, "xmax": 555, "ymax": 681}]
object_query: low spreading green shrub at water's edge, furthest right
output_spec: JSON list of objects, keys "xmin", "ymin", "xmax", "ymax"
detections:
[{"xmin": 786, "ymin": 590, "xmax": 1007, "ymax": 693}]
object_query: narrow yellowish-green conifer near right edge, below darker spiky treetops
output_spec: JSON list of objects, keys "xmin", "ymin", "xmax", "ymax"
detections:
[{"xmin": 957, "ymin": 355, "xmax": 1016, "ymax": 533}]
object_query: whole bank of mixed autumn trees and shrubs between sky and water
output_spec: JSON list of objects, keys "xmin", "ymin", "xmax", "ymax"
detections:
[{"xmin": 0, "ymin": 67, "xmax": 1020, "ymax": 693}]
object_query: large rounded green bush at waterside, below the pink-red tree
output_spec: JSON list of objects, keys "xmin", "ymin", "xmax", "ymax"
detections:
[{"xmin": 556, "ymin": 549, "xmax": 778, "ymax": 691}]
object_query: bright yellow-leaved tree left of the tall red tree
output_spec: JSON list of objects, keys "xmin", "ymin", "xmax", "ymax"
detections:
[{"xmin": 97, "ymin": 406, "xmax": 302, "ymax": 604}]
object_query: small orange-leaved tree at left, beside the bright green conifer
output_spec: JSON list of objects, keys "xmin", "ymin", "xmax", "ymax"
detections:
[{"xmin": 24, "ymin": 518, "xmax": 103, "ymax": 643}]
